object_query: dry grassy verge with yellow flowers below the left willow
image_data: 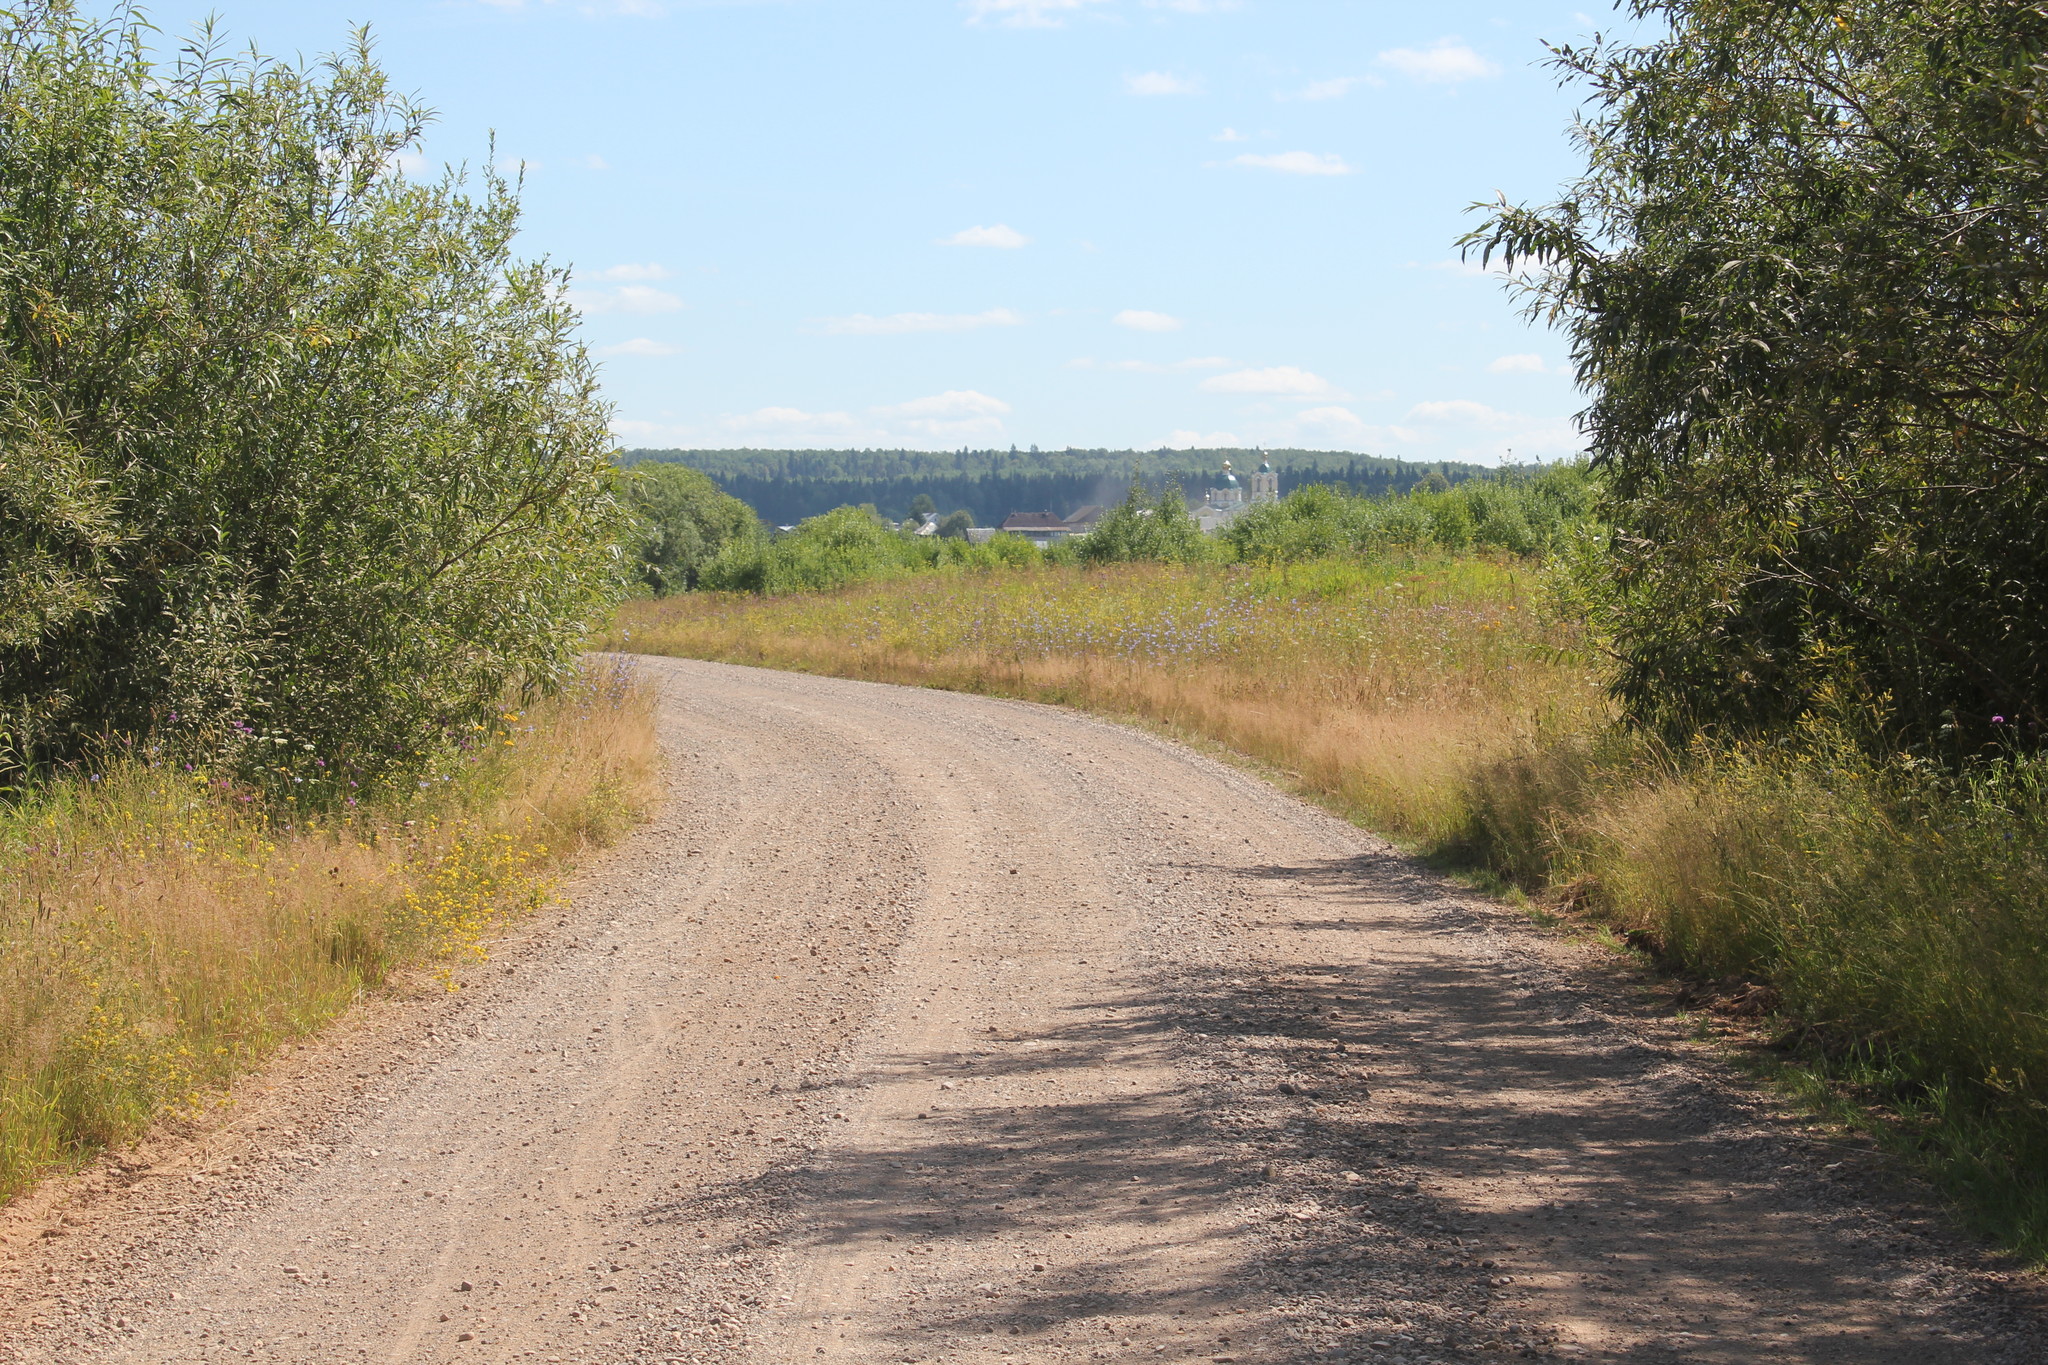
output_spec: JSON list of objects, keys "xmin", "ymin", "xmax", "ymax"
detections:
[{"xmin": 0, "ymin": 667, "xmax": 653, "ymax": 1201}]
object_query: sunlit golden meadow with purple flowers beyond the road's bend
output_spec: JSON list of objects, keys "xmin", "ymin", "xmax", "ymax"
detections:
[{"xmin": 606, "ymin": 557, "xmax": 1606, "ymax": 845}]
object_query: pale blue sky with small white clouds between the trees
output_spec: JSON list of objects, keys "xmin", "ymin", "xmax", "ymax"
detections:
[{"xmin": 140, "ymin": 0, "xmax": 1612, "ymax": 463}]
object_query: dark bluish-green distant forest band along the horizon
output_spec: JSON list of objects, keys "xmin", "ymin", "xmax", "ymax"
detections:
[{"xmin": 618, "ymin": 446, "xmax": 1493, "ymax": 526}]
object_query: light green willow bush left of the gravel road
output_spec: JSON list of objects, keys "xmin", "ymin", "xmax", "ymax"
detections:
[{"xmin": 0, "ymin": 0, "xmax": 618, "ymax": 785}]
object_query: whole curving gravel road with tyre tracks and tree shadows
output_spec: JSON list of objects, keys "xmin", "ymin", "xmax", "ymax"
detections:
[{"xmin": 0, "ymin": 659, "xmax": 2048, "ymax": 1365}]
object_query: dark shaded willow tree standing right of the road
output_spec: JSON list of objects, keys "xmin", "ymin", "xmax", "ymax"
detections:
[{"xmin": 1466, "ymin": 0, "xmax": 2048, "ymax": 755}]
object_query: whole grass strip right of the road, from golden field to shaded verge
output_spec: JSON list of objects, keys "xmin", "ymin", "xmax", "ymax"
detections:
[{"xmin": 606, "ymin": 555, "xmax": 2048, "ymax": 1261}]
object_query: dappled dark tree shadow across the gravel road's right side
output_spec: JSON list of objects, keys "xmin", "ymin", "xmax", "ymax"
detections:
[{"xmin": 647, "ymin": 857, "xmax": 2015, "ymax": 1365}]
